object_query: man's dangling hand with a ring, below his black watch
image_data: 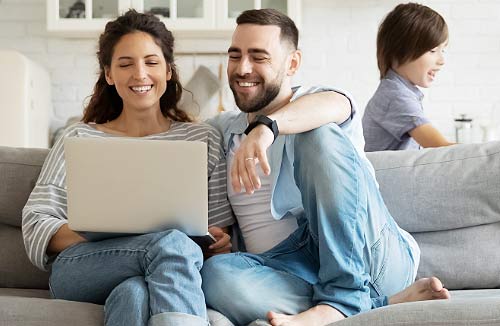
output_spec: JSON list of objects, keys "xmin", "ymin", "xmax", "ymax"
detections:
[{"xmin": 231, "ymin": 125, "xmax": 274, "ymax": 194}]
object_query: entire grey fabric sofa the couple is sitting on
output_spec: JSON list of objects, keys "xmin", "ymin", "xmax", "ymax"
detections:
[{"xmin": 0, "ymin": 142, "xmax": 500, "ymax": 326}]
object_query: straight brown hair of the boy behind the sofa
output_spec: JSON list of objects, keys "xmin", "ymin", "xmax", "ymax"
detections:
[{"xmin": 377, "ymin": 2, "xmax": 448, "ymax": 79}]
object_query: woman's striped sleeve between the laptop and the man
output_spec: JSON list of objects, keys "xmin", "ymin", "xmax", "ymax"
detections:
[{"xmin": 207, "ymin": 127, "xmax": 234, "ymax": 227}]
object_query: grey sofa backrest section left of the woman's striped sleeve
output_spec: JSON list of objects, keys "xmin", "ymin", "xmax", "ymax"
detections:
[{"xmin": 0, "ymin": 146, "xmax": 48, "ymax": 289}]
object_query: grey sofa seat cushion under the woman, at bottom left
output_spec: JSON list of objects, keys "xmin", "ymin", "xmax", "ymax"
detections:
[{"xmin": 0, "ymin": 288, "xmax": 233, "ymax": 326}]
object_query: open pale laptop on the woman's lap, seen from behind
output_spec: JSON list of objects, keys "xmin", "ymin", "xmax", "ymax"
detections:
[{"xmin": 64, "ymin": 137, "xmax": 208, "ymax": 236}]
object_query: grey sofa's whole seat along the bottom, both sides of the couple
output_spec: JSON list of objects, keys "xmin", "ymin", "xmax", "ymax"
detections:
[{"xmin": 4, "ymin": 288, "xmax": 500, "ymax": 326}]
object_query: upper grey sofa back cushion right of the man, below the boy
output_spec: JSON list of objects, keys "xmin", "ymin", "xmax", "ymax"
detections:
[{"xmin": 368, "ymin": 141, "xmax": 500, "ymax": 232}]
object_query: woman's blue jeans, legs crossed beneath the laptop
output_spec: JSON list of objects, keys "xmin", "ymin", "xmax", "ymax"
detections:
[{"xmin": 50, "ymin": 230, "xmax": 208, "ymax": 326}]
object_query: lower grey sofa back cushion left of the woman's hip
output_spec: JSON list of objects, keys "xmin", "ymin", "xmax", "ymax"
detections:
[{"xmin": 0, "ymin": 224, "xmax": 49, "ymax": 288}]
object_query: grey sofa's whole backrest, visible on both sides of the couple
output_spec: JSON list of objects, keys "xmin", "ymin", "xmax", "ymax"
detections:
[{"xmin": 0, "ymin": 142, "xmax": 500, "ymax": 289}]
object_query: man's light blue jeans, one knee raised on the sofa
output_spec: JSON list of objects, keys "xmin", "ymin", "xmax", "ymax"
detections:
[{"xmin": 202, "ymin": 125, "xmax": 419, "ymax": 325}]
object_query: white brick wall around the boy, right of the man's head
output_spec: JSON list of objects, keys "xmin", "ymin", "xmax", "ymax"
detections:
[{"xmin": 294, "ymin": 0, "xmax": 500, "ymax": 139}]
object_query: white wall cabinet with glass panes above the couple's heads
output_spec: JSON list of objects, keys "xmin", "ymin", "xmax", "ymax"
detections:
[{"xmin": 47, "ymin": 0, "xmax": 300, "ymax": 39}]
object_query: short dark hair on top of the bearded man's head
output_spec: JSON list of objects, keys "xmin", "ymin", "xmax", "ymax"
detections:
[{"xmin": 236, "ymin": 9, "xmax": 299, "ymax": 50}]
